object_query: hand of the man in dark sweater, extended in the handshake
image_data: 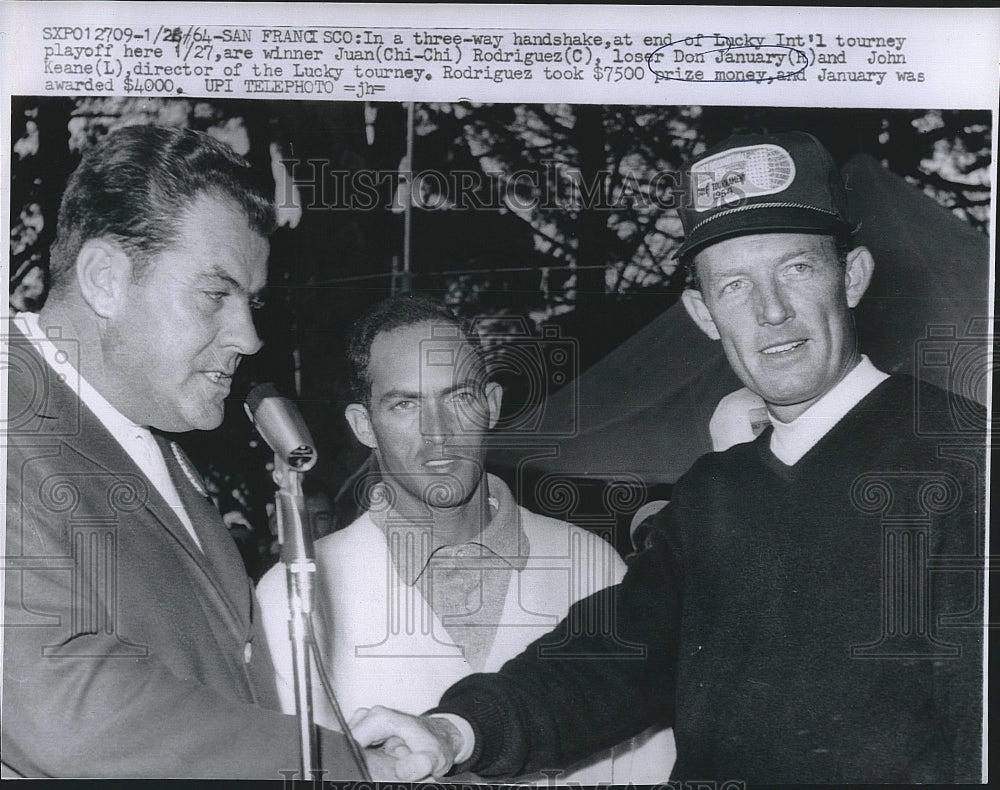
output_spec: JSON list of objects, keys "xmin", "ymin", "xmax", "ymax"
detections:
[{"xmin": 348, "ymin": 705, "xmax": 462, "ymax": 782}]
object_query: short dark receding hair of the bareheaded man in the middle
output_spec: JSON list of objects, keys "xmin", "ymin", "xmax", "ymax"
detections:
[{"xmin": 347, "ymin": 291, "xmax": 479, "ymax": 406}]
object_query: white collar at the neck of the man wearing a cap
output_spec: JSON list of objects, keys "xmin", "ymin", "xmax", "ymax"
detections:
[{"xmin": 771, "ymin": 355, "xmax": 889, "ymax": 466}]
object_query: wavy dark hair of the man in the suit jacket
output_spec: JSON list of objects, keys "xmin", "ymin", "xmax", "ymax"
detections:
[{"xmin": 49, "ymin": 125, "xmax": 275, "ymax": 287}]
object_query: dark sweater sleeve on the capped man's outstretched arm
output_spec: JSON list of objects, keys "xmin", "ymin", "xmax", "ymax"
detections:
[{"xmin": 432, "ymin": 506, "xmax": 682, "ymax": 777}]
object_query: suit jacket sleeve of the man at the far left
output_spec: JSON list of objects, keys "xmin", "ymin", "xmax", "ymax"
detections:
[{"xmin": 2, "ymin": 486, "xmax": 359, "ymax": 780}]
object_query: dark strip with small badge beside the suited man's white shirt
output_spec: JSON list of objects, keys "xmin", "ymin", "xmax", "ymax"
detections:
[{"xmin": 152, "ymin": 431, "xmax": 247, "ymax": 616}]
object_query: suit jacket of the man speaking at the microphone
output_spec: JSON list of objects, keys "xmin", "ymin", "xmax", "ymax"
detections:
[{"xmin": 2, "ymin": 329, "xmax": 358, "ymax": 779}]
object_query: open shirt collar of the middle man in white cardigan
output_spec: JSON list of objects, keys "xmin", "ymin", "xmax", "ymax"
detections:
[{"xmin": 368, "ymin": 475, "xmax": 528, "ymax": 586}]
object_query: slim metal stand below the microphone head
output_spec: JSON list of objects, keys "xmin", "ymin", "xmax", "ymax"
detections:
[{"xmin": 274, "ymin": 453, "xmax": 320, "ymax": 779}]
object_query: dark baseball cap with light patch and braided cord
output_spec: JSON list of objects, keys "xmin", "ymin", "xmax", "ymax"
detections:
[{"xmin": 675, "ymin": 132, "xmax": 849, "ymax": 256}]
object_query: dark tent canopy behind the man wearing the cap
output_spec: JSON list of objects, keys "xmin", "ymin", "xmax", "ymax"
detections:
[{"xmin": 491, "ymin": 155, "xmax": 990, "ymax": 485}]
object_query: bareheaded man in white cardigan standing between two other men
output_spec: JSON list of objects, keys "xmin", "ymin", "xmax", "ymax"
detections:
[{"xmin": 257, "ymin": 293, "xmax": 674, "ymax": 785}]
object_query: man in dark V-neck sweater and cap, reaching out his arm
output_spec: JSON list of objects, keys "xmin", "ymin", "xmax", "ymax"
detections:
[{"xmin": 352, "ymin": 133, "xmax": 985, "ymax": 783}]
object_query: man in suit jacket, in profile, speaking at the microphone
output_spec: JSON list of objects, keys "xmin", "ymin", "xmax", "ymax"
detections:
[{"xmin": 2, "ymin": 127, "xmax": 372, "ymax": 779}]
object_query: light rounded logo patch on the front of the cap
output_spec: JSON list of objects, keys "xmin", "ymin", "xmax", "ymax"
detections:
[{"xmin": 691, "ymin": 144, "xmax": 795, "ymax": 211}]
